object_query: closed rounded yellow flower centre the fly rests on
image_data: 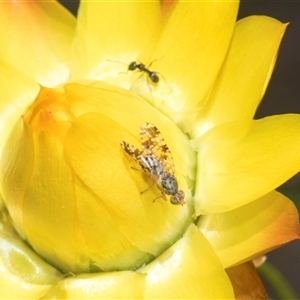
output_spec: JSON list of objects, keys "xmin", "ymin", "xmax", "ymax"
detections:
[{"xmin": 1, "ymin": 83, "xmax": 195, "ymax": 273}]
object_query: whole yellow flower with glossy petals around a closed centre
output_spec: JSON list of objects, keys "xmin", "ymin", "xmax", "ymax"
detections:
[{"xmin": 0, "ymin": 1, "xmax": 300, "ymax": 299}]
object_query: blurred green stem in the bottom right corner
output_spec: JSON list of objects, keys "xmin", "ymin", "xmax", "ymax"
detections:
[{"xmin": 257, "ymin": 261, "xmax": 299, "ymax": 300}]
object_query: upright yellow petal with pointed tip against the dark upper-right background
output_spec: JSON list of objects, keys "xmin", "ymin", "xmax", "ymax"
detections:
[{"xmin": 195, "ymin": 16, "xmax": 287, "ymax": 135}]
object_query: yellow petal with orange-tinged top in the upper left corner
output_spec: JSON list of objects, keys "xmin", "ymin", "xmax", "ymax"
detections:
[{"xmin": 0, "ymin": 1, "xmax": 75, "ymax": 86}]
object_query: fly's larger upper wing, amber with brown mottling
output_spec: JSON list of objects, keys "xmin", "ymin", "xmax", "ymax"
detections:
[{"xmin": 140, "ymin": 123, "xmax": 174, "ymax": 175}]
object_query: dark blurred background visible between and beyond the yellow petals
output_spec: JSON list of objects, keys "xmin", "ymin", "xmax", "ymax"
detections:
[{"xmin": 60, "ymin": 0, "xmax": 300, "ymax": 299}]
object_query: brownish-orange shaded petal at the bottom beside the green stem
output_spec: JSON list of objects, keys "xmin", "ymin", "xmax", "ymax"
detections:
[{"xmin": 226, "ymin": 261, "xmax": 268, "ymax": 300}]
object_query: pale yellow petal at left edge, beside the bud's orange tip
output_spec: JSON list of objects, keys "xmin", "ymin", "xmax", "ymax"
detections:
[{"xmin": 0, "ymin": 60, "xmax": 40, "ymax": 156}]
